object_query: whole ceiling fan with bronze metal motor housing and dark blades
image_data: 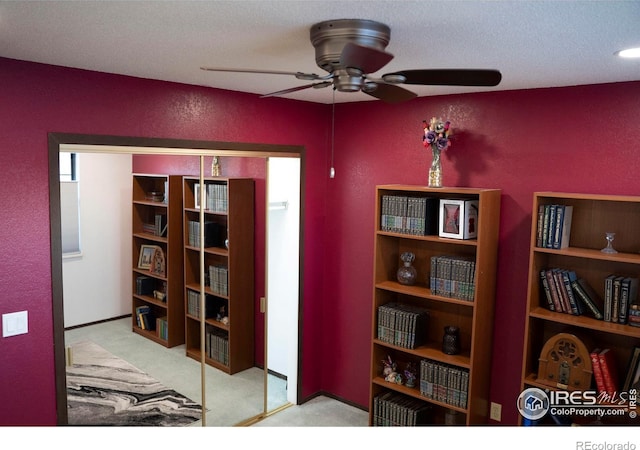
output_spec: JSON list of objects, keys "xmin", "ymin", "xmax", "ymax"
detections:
[{"xmin": 201, "ymin": 19, "xmax": 502, "ymax": 103}]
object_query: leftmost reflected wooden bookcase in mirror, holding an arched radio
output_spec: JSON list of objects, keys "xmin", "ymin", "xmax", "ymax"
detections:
[{"xmin": 132, "ymin": 174, "xmax": 184, "ymax": 347}]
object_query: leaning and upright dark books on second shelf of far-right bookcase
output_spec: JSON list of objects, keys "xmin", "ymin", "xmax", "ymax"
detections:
[{"xmin": 540, "ymin": 268, "xmax": 640, "ymax": 327}]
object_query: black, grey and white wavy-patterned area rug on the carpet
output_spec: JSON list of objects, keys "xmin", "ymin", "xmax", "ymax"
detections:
[{"xmin": 67, "ymin": 341, "xmax": 202, "ymax": 427}]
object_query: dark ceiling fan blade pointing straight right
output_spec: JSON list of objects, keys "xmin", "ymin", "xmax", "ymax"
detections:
[{"xmin": 382, "ymin": 69, "xmax": 502, "ymax": 86}]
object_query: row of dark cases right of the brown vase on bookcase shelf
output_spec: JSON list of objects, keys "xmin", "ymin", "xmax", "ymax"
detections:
[{"xmin": 429, "ymin": 255, "xmax": 476, "ymax": 302}]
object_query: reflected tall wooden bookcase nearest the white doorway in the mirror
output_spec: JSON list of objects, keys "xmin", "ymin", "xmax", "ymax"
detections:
[{"xmin": 183, "ymin": 176, "xmax": 255, "ymax": 374}]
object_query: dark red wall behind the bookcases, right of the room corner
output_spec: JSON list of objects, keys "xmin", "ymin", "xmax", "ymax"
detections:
[{"xmin": 322, "ymin": 82, "xmax": 640, "ymax": 425}]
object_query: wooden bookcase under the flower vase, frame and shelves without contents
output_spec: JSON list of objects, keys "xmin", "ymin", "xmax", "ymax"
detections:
[{"xmin": 369, "ymin": 185, "xmax": 501, "ymax": 425}]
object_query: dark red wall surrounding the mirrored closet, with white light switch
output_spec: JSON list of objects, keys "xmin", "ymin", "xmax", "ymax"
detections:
[{"xmin": 0, "ymin": 58, "xmax": 330, "ymax": 425}]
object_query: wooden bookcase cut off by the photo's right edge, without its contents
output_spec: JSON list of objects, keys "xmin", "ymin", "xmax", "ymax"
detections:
[{"xmin": 521, "ymin": 192, "xmax": 640, "ymax": 425}]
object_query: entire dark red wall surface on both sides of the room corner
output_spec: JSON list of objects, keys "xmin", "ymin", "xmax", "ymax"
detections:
[{"xmin": 0, "ymin": 54, "xmax": 640, "ymax": 425}]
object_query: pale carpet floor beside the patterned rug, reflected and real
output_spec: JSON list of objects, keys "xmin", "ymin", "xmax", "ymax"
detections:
[{"xmin": 65, "ymin": 318, "xmax": 368, "ymax": 428}]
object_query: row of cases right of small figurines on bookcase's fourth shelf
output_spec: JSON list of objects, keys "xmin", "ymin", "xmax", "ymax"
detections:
[{"xmin": 420, "ymin": 359, "xmax": 469, "ymax": 408}]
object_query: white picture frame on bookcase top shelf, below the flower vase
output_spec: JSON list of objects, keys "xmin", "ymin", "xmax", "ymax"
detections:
[{"xmin": 438, "ymin": 198, "xmax": 478, "ymax": 239}]
